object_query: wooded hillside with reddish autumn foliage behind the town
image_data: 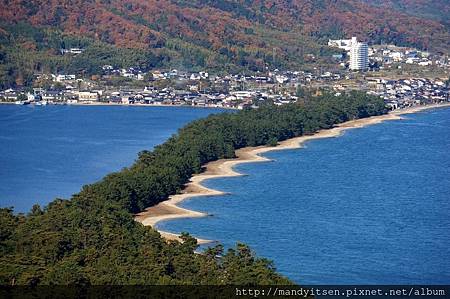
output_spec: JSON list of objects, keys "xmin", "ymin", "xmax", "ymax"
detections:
[{"xmin": 0, "ymin": 0, "xmax": 450, "ymax": 86}]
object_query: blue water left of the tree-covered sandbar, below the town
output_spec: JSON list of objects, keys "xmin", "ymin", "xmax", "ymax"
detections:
[{"xmin": 0, "ymin": 105, "xmax": 223, "ymax": 212}]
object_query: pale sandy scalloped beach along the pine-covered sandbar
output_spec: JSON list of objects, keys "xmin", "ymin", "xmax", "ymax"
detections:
[{"xmin": 135, "ymin": 103, "xmax": 450, "ymax": 244}]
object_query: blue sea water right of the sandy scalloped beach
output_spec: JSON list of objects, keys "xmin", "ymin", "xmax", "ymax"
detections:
[{"xmin": 159, "ymin": 109, "xmax": 450, "ymax": 285}]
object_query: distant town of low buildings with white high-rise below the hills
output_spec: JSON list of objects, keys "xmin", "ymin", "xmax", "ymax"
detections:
[{"xmin": 0, "ymin": 37, "xmax": 450, "ymax": 109}]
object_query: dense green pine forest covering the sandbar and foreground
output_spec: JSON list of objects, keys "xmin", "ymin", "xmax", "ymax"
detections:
[{"xmin": 0, "ymin": 92, "xmax": 386, "ymax": 285}]
